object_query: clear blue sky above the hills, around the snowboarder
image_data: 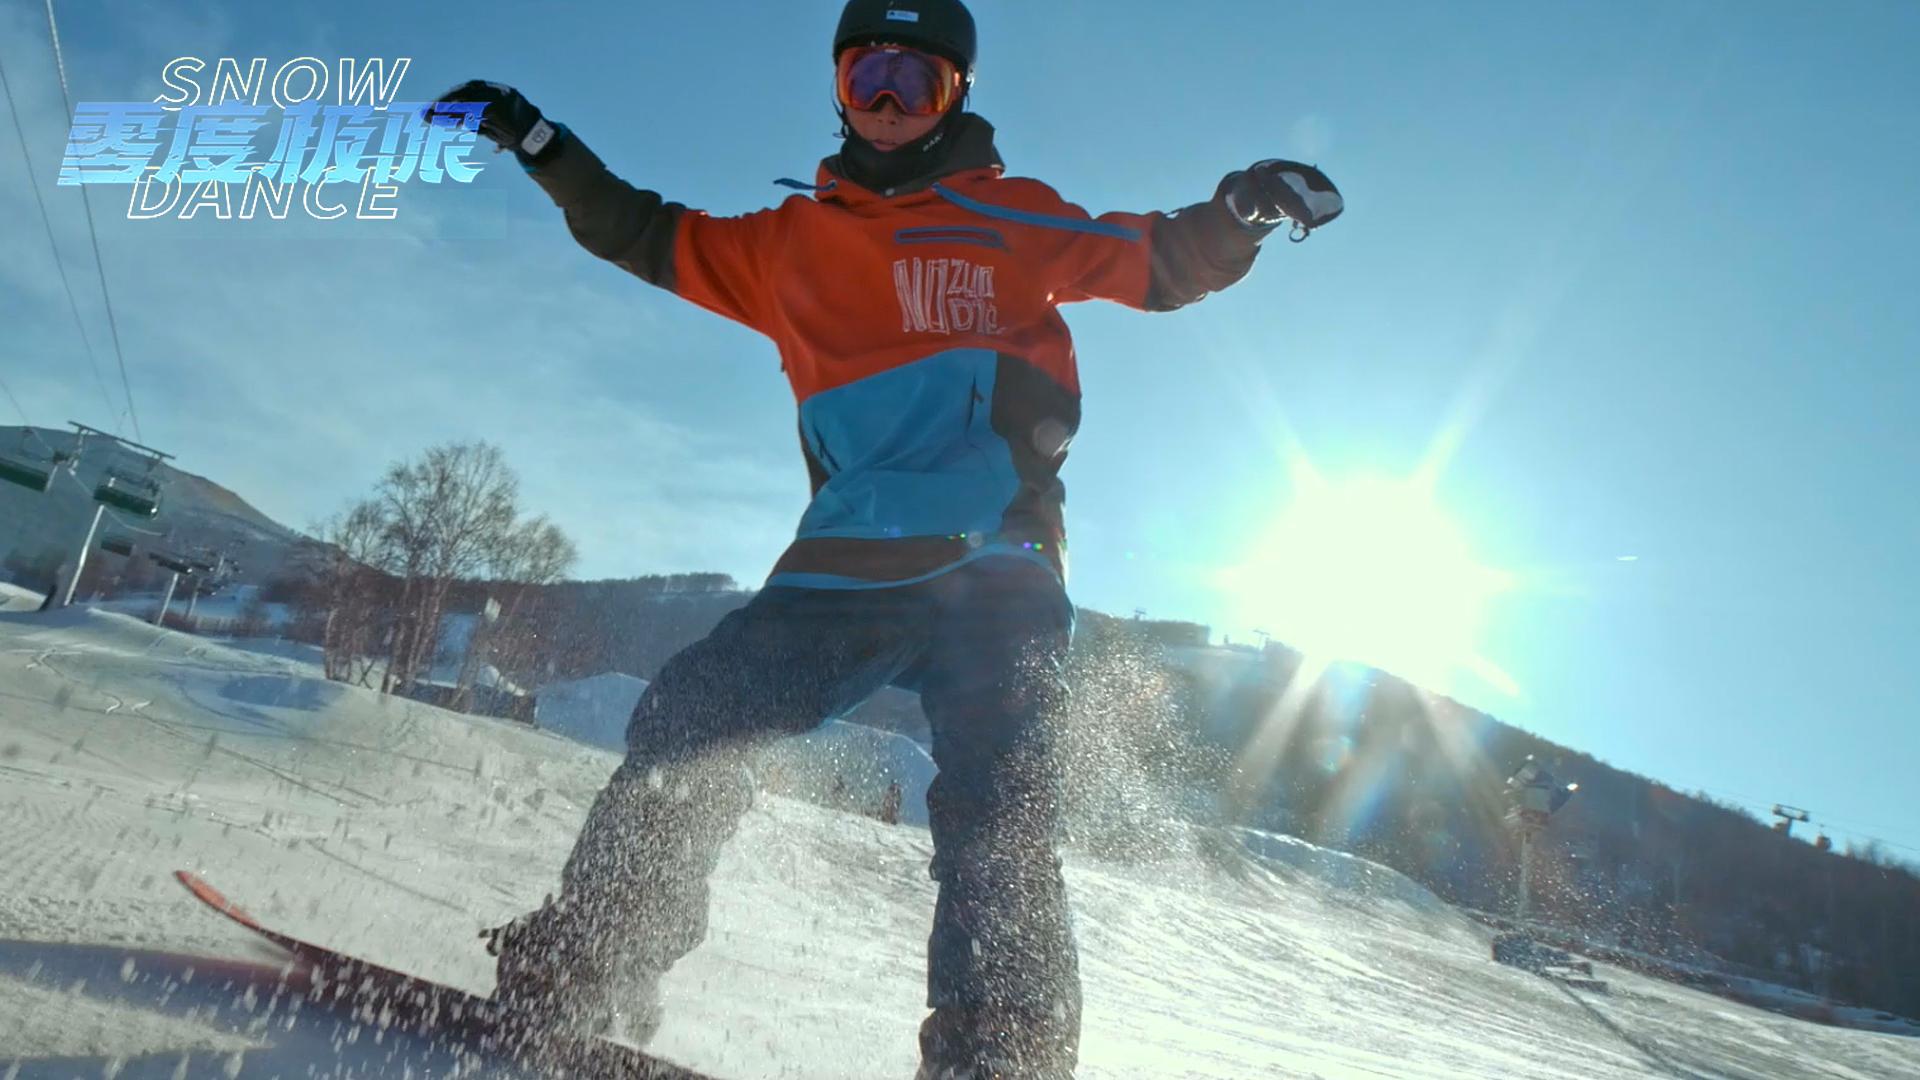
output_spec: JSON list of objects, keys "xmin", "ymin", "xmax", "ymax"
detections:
[{"xmin": 0, "ymin": 0, "xmax": 1920, "ymax": 859}]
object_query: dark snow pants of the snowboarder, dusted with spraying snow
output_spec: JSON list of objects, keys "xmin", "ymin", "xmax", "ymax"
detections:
[{"xmin": 518, "ymin": 557, "xmax": 1081, "ymax": 1074}]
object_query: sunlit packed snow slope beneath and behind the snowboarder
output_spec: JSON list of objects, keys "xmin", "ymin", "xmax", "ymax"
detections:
[{"xmin": 0, "ymin": 611, "xmax": 1920, "ymax": 1080}]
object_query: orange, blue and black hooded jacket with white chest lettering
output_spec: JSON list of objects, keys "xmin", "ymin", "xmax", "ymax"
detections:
[{"xmin": 530, "ymin": 113, "xmax": 1260, "ymax": 588}]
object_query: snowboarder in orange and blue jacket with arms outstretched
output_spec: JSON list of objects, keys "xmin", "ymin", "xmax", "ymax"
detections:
[{"xmin": 434, "ymin": 0, "xmax": 1342, "ymax": 1078}]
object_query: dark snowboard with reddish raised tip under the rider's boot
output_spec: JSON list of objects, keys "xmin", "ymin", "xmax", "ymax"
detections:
[{"xmin": 173, "ymin": 871, "xmax": 714, "ymax": 1080}]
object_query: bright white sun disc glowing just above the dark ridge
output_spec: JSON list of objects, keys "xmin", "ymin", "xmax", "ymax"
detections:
[{"xmin": 1221, "ymin": 469, "xmax": 1515, "ymax": 694}]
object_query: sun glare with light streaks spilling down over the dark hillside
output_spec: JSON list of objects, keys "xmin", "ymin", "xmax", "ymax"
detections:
[{"xmin": 1217, "ymin": 448, "xmax": 1521, "ymax": 822}]
